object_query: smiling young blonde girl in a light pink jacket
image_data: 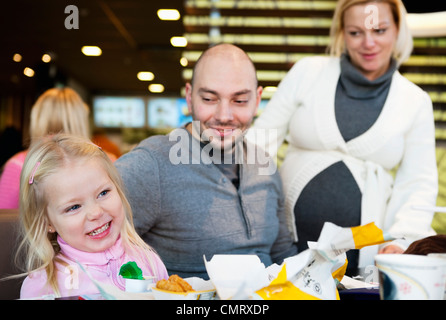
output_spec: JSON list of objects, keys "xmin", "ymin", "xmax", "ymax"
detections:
[{"xmin": 20, "ymin": 134, "xmax": 168, "ymax": 298}]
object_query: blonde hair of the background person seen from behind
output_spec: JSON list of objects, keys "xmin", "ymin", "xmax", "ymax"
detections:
[{"xmin": 30, "ymin": 88, "xmax": 90, "ymax": 141}]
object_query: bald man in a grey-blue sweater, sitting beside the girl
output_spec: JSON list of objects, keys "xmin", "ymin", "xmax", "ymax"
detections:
[{"xmin": 116, "ymin": 44, "xmax": 297, "ymax": 279}]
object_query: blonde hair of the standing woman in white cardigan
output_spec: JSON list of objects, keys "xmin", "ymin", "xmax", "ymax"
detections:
[{"xmin": 328, "ymin": 0, "xmax": 413, "ymax": 66}]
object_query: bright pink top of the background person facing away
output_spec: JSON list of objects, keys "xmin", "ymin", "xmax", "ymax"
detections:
[{"xmin": 0, "ymin": 150, "xmax": 28, "ymax": 209}]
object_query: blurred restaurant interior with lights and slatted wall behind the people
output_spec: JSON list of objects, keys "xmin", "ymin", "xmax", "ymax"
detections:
[{"xmin": 0, "ymin": 0, "xmax": 446, "ymax": 233}]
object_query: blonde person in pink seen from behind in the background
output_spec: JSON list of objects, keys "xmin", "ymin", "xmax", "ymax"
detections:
[{"xmin": 0, "ymin": 88, "xmax": 116, "ymax": 209}]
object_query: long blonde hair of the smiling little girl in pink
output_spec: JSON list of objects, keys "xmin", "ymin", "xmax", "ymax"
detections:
[{"xmin": 17, "ymin": 134, "xmax": 160, "ymax": 295}]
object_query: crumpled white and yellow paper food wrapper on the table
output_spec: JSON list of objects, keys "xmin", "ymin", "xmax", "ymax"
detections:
[{"xmin": 256, "ymin": 222, "xmax": 393, "ymax": 300}]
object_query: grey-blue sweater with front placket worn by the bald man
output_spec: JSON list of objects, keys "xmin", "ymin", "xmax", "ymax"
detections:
[{"xmin": 115, "ymin": 128, "xmax": 296, "ymax": 279}]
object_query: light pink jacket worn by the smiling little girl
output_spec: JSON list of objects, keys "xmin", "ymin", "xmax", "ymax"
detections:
[{"xmin": 20, "ymin": 237, "xmax": 168, "ymax": 299}]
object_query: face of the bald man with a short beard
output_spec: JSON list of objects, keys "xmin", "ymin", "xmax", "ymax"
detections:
[{"xmin": 186, "ymin": 48, "xmax": 262, "ymax": 150}]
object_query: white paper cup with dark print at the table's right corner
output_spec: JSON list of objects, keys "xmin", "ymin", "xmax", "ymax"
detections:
[{"xmin": 375, "ymin": 254, "xmax": 446, "ymax": 300}]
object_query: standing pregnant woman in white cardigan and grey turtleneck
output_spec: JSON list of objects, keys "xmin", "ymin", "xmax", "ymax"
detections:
[{"xmin": 249, "ymin": 0, "xmax": 438, "ymax": 272}]
